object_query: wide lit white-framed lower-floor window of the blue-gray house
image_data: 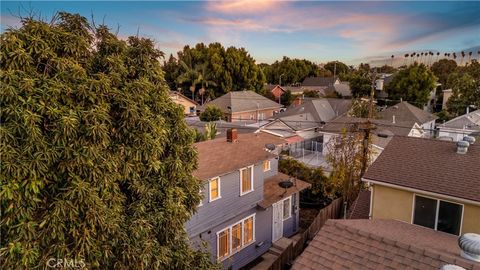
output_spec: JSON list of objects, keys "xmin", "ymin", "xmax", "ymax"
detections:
[{"xmin": 217, "ymin": 215, "xmax": 255, "ymax": 261}]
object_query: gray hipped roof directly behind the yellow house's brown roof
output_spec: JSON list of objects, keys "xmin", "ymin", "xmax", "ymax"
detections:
[{"xmin": 379, "ymin": 101, "xmax": 438, "ymax": 125}]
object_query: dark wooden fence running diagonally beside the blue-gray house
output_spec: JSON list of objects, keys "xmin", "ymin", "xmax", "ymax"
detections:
[{"xmin": 269, "ymin": 198, "xmax": 343, "ymax": 270}]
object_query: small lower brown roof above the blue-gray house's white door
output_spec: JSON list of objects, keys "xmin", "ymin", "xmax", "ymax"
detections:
[{"xmin": 258, "ymin": 173, "xmax": 312, "ymax": 209}]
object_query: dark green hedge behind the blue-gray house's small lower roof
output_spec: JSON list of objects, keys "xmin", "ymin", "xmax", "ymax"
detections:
[{"xmin": 278, "ymin": 158, "xmax": 327, "ymax": 197}]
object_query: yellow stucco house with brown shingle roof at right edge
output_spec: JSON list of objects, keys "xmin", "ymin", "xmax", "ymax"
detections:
[{"xmin": 362, "ymin": 136, "xmax": 480, "ymax": 235}]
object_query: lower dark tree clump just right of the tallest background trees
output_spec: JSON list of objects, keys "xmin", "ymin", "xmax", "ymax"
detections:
[{"xmin": 259, "ymin": 56, "xmax": 319, "ymax": 85}]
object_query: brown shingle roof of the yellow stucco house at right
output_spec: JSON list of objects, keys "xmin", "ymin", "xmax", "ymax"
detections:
[{"xmin": 364, "ymin": 136, "xmax": 480, "ymax": 202}]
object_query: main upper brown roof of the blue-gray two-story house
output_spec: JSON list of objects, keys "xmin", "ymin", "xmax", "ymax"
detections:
[{"xmin": 193, "ymin": 132, "xmax": 285, "ymax": 180}]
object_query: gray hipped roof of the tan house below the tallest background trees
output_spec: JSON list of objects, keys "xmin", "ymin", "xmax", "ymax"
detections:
[{"xmin": 202, "ymin": 91, "xmax": 282, "ymax": 113}]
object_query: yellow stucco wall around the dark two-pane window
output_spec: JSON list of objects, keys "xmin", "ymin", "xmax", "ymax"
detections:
[{"xmin": 372, "ymin": 185, "xmax": 480, "ymax": 234}]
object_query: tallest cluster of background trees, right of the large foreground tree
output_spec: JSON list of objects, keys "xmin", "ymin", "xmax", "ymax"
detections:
[{"xmin": 163, "ymin": 43, "xmax": 265, "ymax": 99}]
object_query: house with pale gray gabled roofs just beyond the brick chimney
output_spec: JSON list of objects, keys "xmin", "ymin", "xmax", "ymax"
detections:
[{"xmin": 259, "ymin": 98, "xmax": 352, "ymax": 142}]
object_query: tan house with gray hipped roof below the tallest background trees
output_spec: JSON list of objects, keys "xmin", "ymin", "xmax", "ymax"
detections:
[{"xmin": 201, "ymin": 91, "xmax": 282, "ymax": 123}]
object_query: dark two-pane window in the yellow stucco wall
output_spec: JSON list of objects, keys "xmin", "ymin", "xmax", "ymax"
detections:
[{"xmin": 413, "ymin": 195, "xmax": 463, "ymax": 235}]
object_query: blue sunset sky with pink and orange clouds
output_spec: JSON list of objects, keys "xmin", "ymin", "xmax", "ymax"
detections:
[{"xmin": 0, "ymin": 0, "xmax": 480, "ymax": 65}]
